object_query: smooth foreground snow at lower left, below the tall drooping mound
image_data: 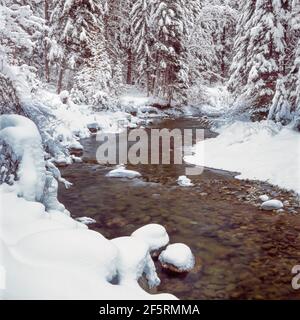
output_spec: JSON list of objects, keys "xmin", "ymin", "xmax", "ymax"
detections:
[{"xmin": 0, "ymin": 184, "xmax": 175, "ymax": 300}]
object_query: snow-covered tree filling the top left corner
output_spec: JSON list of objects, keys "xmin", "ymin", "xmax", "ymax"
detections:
[{"xmin": 0, "ymin": 0, "xmax": 43, "ymax": 114}]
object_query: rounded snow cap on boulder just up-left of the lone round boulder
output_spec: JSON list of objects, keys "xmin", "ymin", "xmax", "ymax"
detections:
[{"xmin": 131, "ymin": 223, "xmax": 169, "ymax": 252}]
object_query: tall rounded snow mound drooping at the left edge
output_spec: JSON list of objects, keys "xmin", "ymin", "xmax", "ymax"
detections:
[{"xmin": 0, "ymin": 115, "xmax": 46, "ymax": 201}]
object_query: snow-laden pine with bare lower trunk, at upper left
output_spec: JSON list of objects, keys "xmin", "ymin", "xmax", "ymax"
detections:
[{"xmin": 49, "ymin": 0, "xmax": 104, "ymax": 93}]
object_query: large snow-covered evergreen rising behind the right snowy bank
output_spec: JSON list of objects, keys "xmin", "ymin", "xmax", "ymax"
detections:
[{"xmin": 229, "ymin": 0, "xmax": 286, "ymax": 119}]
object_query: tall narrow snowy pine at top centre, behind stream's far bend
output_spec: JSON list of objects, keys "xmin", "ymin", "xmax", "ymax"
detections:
[{"xmin": 153, "ymin": 0, "xmax": 188, "ymax": 104}]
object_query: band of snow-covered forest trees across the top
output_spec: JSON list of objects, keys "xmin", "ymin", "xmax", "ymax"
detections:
[{"xmin": 0, "ymin": 0, "xmax": 300, "ymax": 123}]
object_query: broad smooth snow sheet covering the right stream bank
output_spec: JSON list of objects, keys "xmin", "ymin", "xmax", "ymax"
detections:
[{"xmin": 185, "ymin": 121, "xmax": 300, "ymax": 193}]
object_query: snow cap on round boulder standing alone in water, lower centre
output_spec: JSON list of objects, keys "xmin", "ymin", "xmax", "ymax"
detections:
[{"xmin": 158, "ymin": 243, "xmax": 195, "ymax": 272}]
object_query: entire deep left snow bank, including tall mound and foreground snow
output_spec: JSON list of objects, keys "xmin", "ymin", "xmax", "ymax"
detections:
[{"xmin": 0, "ymin": 115, "xmax": 175, "ymax": 300}]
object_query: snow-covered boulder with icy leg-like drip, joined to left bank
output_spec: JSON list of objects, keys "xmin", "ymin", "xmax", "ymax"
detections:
[{"xmin": 111, "ymin": 237, "xmax": 160, "ymax": 288}]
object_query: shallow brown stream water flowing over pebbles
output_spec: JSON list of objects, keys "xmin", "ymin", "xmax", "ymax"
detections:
[{"xmin": 59, "ymin": 119, "xmax": 300, "ymax": 299}]
